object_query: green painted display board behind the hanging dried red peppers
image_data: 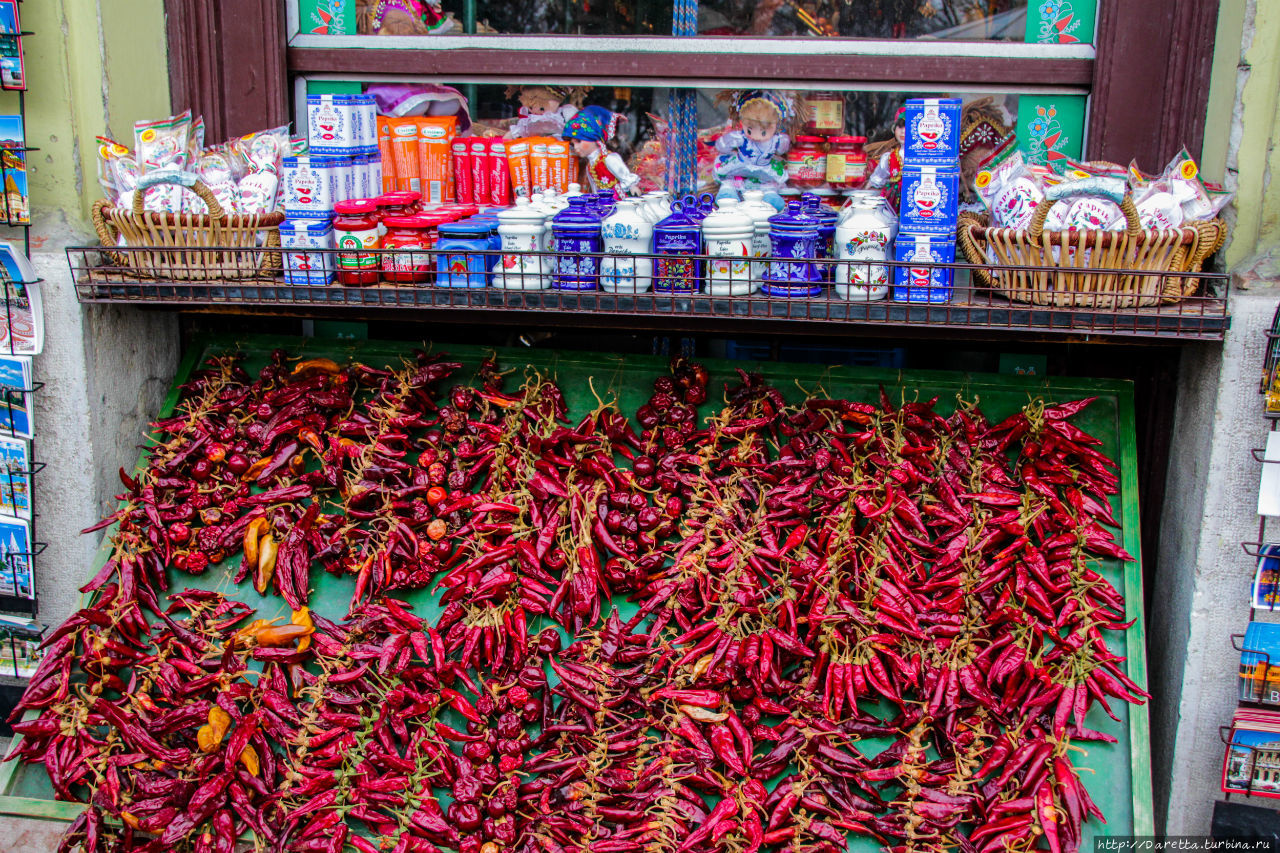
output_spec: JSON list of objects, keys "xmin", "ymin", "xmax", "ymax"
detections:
[{"xmin": 0, "ymin": 337, "xmax": 1153, "ymax": 850}]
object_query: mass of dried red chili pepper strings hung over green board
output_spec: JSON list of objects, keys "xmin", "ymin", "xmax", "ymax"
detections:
[{"xmin": 7, "ymin": 352, "xmax": 1146, "ymax": 853}]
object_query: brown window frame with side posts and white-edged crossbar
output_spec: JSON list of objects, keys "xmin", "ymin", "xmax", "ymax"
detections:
[{"xmin": 165, "ymin": 0, "xmax": 1219, "ymax": 176}]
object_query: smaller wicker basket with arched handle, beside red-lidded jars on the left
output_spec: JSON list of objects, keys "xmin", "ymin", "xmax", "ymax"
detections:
[{"xmin": 93, "ymin": 172, "xmax": 284, "ymax": 282}]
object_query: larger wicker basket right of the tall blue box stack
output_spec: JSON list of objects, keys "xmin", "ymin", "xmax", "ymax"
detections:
[{"xmin": 959, "ymin": 186, "xmax": 1225, "ymax": 310}]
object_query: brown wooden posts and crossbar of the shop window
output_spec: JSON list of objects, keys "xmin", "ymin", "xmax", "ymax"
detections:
[{"xmin": 165, "ymin": 0, "xmax": 1219, "ymax": 175}]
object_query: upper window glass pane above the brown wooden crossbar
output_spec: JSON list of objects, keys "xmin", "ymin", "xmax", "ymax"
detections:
[{"xmin": 291, "ymin": 0, "xmax": 1097, "ymax": 44}]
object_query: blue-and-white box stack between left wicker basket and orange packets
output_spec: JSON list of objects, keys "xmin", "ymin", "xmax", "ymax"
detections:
[{"xmin": 280, "ymin": 95, "xmax": 383, "ymax": 286}]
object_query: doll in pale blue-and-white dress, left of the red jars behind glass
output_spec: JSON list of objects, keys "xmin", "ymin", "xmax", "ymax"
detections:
[{"xmin": 716, "ymin": 88, "xmax": 803, "ymax": 210}]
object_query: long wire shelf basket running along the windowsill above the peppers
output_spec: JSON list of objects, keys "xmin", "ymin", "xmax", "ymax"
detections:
[{"xmin": 67, "ymin": 247, "xmax": 1230, "ymax": 342}]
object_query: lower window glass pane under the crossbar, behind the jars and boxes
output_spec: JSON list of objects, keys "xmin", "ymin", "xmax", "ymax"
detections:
[{"xmin": 300, "ymin": 81, "xmax": 1085, "ymax": 201}]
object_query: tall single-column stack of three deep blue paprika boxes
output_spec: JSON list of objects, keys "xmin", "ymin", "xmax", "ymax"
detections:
[{"xmin": 893, "ymin": 97, "xmax": 961, "ymax": 302}]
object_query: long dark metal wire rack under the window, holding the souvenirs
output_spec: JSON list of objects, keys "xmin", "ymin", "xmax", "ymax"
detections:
[{"xmin": 67, "ymin": 246, "xmax": 1230, "ymax": 342}]
